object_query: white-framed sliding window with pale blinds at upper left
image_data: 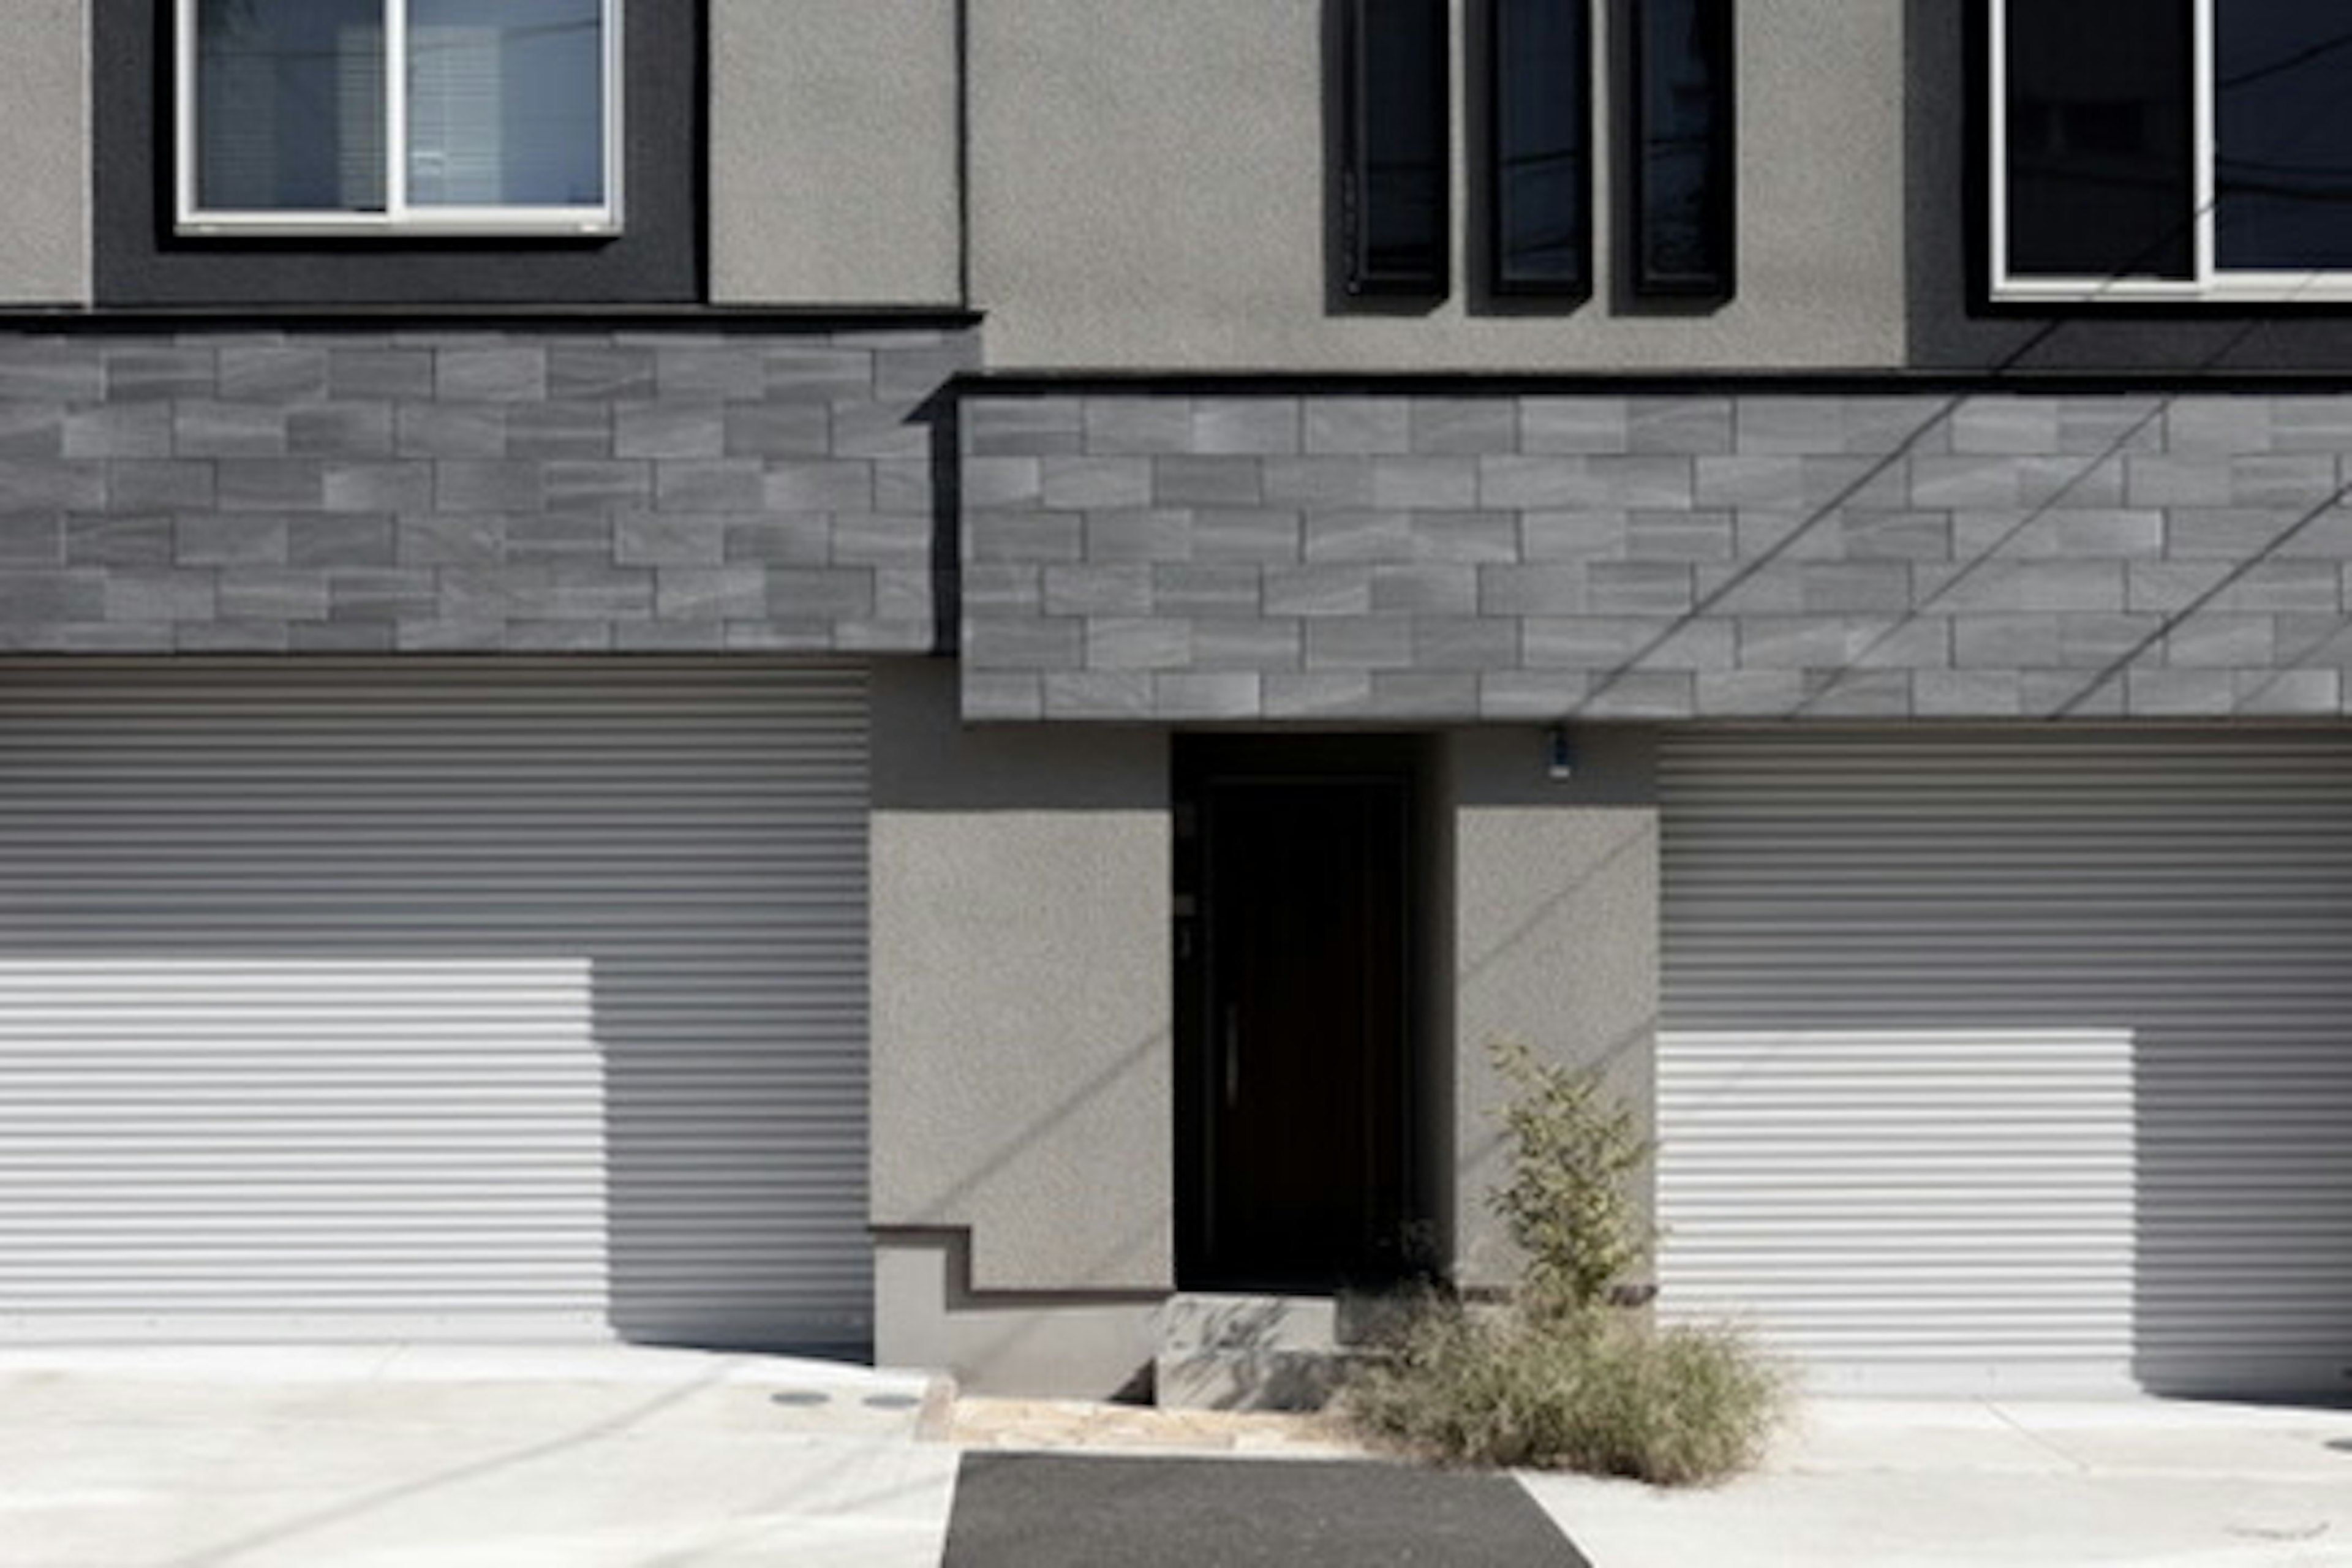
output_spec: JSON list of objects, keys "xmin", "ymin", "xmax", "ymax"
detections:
[{"xmin": 174, "ymin": 0, "xmax": 621, "ymax": 235}]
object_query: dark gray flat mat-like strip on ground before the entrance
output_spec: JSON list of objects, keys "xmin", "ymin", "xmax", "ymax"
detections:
[{"xmin": 943, "ymin": 1453, "xmax": 1593, "ymax": 1568}]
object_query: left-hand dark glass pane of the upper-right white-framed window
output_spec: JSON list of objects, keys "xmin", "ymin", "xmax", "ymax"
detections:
[{"xmin": 2004, "ymin": 0, "xmax": 2197, "ymax": 277}]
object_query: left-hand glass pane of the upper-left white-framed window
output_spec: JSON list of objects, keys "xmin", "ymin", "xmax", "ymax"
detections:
[{"xmin": 195, "ymin": 0, "xmax": 383, "ymax": 211}]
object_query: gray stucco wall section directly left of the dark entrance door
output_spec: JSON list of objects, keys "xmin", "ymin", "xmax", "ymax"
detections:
[{"xmin": 870, "ymin": 661, "xmax": 1174, "ymax": 1291}]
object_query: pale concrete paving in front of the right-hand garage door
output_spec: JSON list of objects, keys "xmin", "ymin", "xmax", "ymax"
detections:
[{"xmin": 1521, "ymin": 1399, "xmax": 2352, "ymax": 1568}]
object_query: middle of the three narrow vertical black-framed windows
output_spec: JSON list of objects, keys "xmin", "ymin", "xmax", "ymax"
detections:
[{"xmin": 1487, "ymin": 0, "xmax": 1593, "ymax": 298}]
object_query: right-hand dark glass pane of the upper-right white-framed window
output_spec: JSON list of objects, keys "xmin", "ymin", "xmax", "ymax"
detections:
[{"xmin": 2213, "ymin": 0, "xmax": 2352, "ymax": 270}]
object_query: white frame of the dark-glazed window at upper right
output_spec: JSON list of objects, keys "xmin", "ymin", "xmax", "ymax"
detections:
[{"xmin": 1985, "ymin": 0, "xmax": 2352, "ymax": 306}]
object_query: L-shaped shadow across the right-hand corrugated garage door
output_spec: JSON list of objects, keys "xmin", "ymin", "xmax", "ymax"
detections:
[{"xmin": 1665, "ymin": 731, "xmax": 2352, "ymax": 1399}]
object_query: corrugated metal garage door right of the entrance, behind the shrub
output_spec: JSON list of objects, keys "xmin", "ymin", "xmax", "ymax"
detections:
[{"xmin": 1658, "ymin": 731, "xmax": 2352, "ymax": 1396}]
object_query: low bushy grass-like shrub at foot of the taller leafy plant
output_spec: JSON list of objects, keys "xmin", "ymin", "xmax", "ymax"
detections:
[{"xmin": 1345, "ymin": 1300, "xmax": 1785, "ymax": 1486}]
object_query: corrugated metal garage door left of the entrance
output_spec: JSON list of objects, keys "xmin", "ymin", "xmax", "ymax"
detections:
[{"xmin": 0, "ymin": 661, "xmax": 870, "ymax": 1344}]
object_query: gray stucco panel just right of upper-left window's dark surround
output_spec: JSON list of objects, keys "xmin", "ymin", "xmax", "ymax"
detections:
[{"xmin": 710, "ymin": 0, "xmax": 962, "ymax": 306}]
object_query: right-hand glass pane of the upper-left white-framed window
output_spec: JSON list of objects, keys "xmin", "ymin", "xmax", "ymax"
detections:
[{"xmin": 409, "ymin": 0, "xmax": 605, "ymax": 207}]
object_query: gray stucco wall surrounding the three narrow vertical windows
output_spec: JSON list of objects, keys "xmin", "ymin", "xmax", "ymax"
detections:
[{"xmin": 969, "ymin": 0, "xmax": 1905, "ymax": 371}]
